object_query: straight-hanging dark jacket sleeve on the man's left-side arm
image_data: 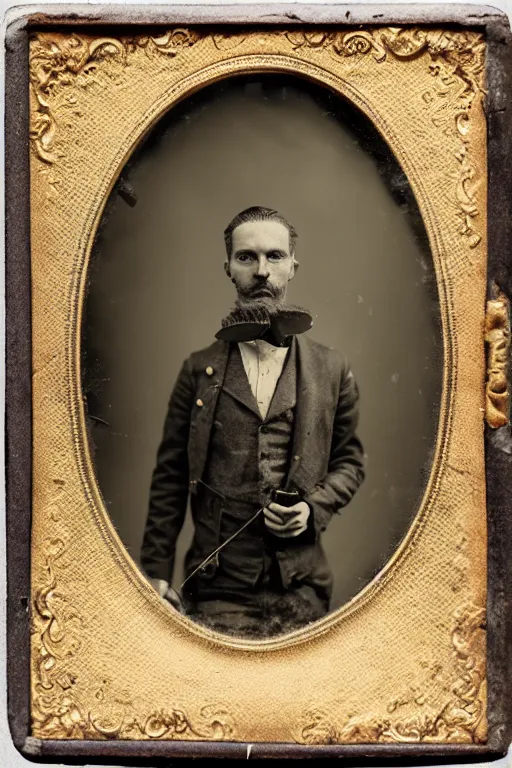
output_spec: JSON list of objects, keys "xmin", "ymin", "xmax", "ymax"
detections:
[{"xmin": 141, "ymin": 359, "xmax": 195, "ymax": 582}]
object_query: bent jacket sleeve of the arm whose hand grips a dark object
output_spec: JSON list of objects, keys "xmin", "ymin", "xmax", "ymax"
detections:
[{"xmin": 304, "ymin": 364, "xmax": 365, "ymax": 537}]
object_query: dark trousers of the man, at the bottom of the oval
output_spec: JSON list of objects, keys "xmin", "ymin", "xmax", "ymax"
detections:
[{"xmin": 183, "ymin": 488, "xmax": 329, "ymax": 638}]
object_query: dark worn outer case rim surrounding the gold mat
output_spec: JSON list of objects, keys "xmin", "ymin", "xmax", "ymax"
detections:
[{"xmin": 5, "ymin": 4, "xmax": 512, "ymax": 766}]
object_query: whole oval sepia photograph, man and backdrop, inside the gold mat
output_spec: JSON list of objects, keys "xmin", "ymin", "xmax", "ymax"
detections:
[{"xmin": 83, "ymin": 75, "xmax": 442, "ymax": 639}]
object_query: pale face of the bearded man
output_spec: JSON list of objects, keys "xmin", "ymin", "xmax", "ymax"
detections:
[{"xmin": 225, "ymin": 221, "xmax": 295, "ymax": 302}]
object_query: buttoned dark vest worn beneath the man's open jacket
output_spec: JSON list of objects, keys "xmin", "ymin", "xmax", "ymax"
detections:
[{"xmin": 196, "ymin": 345, "xmax": 297, "ymax": 585}]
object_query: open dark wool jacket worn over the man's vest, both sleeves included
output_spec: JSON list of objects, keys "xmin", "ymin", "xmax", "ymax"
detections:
[{"xmin": 141, "ymin": 336, "xmax": 364, "ymax": 586}]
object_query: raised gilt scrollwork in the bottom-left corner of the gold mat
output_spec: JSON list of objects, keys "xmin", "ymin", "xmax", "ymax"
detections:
[{"xmin": 31, "ymin": 538, "xmax": 235, "ymax": 741}]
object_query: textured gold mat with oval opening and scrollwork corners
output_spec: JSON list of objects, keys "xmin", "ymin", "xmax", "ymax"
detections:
[{"xmin": 30, "ymin": 28, "xmax": 486, "ymax": 743}]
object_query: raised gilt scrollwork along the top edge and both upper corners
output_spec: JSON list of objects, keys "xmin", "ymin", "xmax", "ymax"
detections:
[{"xmin": 30, "ymin": 27, "xmax": 485, "ymax": 249}]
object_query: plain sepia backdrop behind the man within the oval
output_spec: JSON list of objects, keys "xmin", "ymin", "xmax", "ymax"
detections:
[{"xmin": 82, "ymin": 75, "xmax": 442, "ymax": 607}]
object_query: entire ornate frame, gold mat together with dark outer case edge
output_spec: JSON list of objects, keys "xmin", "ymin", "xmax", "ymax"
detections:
[{"xmin": 6, "ymin": 5, "xmax": 512, "ymax": 761}]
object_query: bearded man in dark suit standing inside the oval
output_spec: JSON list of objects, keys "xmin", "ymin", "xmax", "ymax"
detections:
[{"xmin": 141, "ymin": 207, "xmax": 364, "ymax": 637}]
